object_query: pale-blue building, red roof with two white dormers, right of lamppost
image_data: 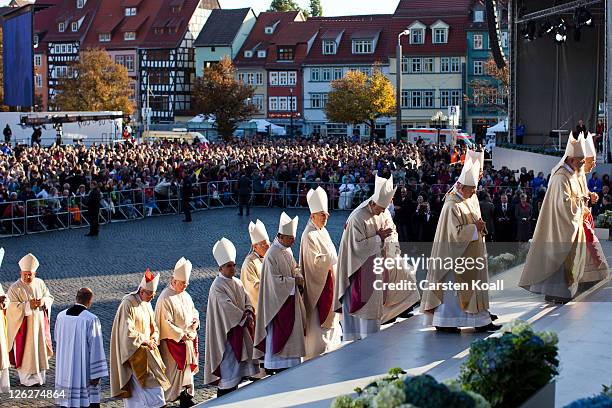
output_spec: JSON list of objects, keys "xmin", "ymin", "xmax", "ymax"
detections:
[{"xmin": 388, "ymin": 0, "xmax": 471, "ymax": 130}]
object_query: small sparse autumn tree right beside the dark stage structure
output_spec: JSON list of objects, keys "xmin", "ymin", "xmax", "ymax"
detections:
[{"xmin": 467, "ymin": 58, "xmax": 510, "ymax": 113}]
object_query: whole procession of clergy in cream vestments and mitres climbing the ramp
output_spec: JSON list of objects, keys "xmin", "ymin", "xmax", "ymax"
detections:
[{"xmin": 0, "ymin": 134, "xmax": 609, "ymax": 408}]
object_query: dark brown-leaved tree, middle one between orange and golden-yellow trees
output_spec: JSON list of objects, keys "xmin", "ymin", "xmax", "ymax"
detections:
[{"xmin": 191, "ymin": 57, "xmax": 257, "ymax": 140}]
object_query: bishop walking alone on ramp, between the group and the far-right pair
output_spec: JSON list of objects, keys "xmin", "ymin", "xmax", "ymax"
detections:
[{"xmin": 421, "ymin": 159, "xmax": 501, "ymax": 333}]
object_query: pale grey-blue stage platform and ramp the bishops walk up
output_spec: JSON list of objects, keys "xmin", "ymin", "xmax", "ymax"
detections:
[{"xmin": 199, "ymin": 242, "xmax": 612, "ymax": 408}]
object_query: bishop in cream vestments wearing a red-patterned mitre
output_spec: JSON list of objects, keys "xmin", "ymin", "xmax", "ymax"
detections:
[{"xmin": 110, "ymin": 269, "xmax": 170, "ymax": 408}]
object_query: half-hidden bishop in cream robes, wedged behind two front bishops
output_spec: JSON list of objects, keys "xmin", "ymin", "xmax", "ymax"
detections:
[{"xmin": 240, "ymin": 220, "xmax": 270, "ymax": 313}]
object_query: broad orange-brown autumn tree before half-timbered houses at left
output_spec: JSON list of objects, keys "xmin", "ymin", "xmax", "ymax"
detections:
[{"xmin": 52, "ymin": 48, "xmax": 134, "ymax": 114}]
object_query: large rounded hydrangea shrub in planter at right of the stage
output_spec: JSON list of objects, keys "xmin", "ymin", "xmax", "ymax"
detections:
[{"xmin": 459, "ymin": 320, "xmax": 559, "ymax": 408}]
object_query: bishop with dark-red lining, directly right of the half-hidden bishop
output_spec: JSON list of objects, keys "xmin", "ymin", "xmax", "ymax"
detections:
[{"xmin": 255, "ymin": 212, "xmax": 306, "ymax": 374}]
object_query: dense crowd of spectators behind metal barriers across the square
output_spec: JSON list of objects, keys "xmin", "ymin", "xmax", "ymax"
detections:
[{"xmin": 0, "ymin": 138, "xmax": 610, "ymax": 241}]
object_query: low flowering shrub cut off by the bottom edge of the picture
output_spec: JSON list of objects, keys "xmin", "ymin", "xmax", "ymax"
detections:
[{"xmin": 332, "ymin": 368, "xmax": 491, "ymax": 408}]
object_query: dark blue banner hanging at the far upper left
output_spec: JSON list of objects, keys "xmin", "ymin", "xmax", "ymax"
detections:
[{"xmin": 2, "ymin": 11, "xmax": 34, "ymax": 107}]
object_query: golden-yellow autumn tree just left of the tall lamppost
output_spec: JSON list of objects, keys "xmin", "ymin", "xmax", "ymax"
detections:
[{"xmin": 326, "ymin": 68, "xmax": 395, "ymax": 134}]
